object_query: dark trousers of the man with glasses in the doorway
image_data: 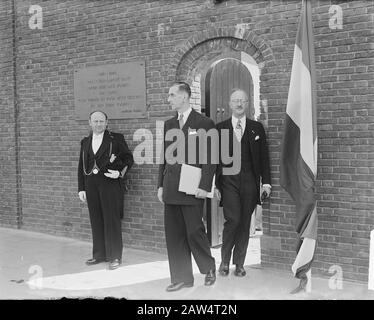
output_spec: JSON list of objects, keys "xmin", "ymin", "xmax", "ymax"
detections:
[{"xmin": 221, "ymin": 171, "xmax": 257, "ymax": 266}]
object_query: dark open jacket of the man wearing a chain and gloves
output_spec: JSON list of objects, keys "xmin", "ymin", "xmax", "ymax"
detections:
[{"xmin": 78, "ymin": 130, "xmax": 134, "ymax": 191}]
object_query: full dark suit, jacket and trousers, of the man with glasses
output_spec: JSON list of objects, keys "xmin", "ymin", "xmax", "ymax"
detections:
[{"xmin": 216, "ymin": 117, "xmax": 270, "ymax": 266}]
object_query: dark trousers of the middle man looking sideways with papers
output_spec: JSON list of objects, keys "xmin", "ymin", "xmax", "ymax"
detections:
[{"xmin": 165, "ymin": 201, "xmax": 215, "ymax": 283}]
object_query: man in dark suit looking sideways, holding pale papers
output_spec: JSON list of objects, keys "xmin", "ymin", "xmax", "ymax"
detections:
[{"xmin": 158, "ymin": 82, "xmax": 216, "ymax": 291}]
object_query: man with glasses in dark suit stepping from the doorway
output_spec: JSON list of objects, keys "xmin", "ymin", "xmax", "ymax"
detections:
[{"xmin": 216, "ymin": 89, "xmax": 271, "ymax": 277}]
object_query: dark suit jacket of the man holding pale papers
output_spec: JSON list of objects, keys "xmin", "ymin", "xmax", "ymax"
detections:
[{"xmin": 158, "ymin": 109, "xmax": 217, "ymax": 205}]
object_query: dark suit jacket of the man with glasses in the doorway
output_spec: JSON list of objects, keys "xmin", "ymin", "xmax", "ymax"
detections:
[{"xmin": 216, "ymin": 117, "xmax": 271, "ymax": 204}]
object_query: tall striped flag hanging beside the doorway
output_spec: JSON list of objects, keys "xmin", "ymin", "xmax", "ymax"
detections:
[{"xmin": 280, "ymin": 0, "xmax": 317, "ymax": 279}]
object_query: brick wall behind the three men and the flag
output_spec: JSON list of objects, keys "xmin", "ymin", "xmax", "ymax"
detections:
[{"xmin": 0, "ymin": 0, "xmax": 374, "ymax": 281}]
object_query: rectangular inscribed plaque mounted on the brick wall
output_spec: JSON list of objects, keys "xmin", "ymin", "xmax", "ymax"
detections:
[{"xmin": 74, "ymin": 61, "xmax": 146, "ymax": 120}]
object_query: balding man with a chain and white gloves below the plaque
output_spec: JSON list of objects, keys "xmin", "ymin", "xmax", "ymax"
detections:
[{"xmin": 78, "ymin": 111, "xmax": 134, "ymax": 270}]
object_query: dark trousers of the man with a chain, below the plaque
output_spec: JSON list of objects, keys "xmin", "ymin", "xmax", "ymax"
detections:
[{"xmin": 86, "ymin": 174, "xmax": 123, "ymax": 261}]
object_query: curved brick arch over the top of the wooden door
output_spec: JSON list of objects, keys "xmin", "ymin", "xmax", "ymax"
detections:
[{"xmin": 172, "ymin": 27, "xmax": 275, "ymax": 82}]
